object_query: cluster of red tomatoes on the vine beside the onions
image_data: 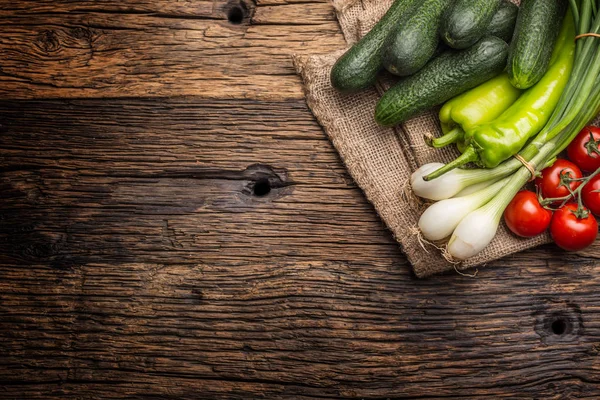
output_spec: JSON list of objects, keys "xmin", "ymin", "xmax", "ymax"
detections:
[{"xmin": 504, "ymin": 126, "xmax": 600, "ymax": 251}]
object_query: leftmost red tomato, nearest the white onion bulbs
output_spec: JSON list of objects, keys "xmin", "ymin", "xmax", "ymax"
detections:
[{"xmin": 504, "ymin": 190, "xmax": 552, "ymax": 237}]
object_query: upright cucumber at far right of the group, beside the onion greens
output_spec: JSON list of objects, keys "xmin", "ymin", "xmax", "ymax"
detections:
[{"xmin": 508, "ymin": 0, "xmax": 567, "ymax": 89}]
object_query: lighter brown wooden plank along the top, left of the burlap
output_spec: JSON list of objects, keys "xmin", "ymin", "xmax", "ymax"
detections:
[{"xmin": 0, "ymin": 0, "xmax": 344, "ymax": 100}]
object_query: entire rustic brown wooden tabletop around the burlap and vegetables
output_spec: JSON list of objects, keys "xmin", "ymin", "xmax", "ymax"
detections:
[{"xmin": 0, "ymin": 0, "xmax": 600, "ymax": 400}]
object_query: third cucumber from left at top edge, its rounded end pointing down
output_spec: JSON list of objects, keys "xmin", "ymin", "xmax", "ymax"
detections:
[{"xmin": 440, "ymin": 0, "xmax": 502, "ymax": 49}]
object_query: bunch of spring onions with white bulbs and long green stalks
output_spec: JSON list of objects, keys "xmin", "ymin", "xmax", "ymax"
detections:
[{"xmin": 412, "ymin": 0, "xmax": 600, "ymax": 260}]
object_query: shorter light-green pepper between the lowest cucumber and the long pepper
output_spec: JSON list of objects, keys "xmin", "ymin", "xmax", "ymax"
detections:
[{"xmin": 430, "ymin": 72, "xmax": 522, "ymax": 148}]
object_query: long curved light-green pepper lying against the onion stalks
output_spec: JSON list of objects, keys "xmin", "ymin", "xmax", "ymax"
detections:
[{"xmin": 425, "ymin": 12, "xmax": 575, "ymax": 180}]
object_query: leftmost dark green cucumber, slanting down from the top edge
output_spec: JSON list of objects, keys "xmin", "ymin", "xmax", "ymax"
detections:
[{"xmin": 331, "ymin": 0, "xmax": 420, "ymax": 92}]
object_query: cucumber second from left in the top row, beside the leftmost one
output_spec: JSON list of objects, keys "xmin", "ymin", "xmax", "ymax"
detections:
[{"xmin": 383, "ymin": 0, "xmax": 452, "ymax": 76}]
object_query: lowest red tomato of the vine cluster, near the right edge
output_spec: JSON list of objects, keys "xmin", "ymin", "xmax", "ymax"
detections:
[{"xmin": 550, "ymin": 203, "xmax": 598, "ymax": 251}]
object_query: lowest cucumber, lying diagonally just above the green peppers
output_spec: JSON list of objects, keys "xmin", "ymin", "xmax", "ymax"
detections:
[{"xmin": 375, "ymin": 36, "xmax": 508, "ymax": 126}]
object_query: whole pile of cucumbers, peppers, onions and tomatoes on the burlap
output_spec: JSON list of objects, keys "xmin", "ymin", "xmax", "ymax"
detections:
[{"xmin": 331, "ymin": 0, "xmax": 600, "ymax": 261}]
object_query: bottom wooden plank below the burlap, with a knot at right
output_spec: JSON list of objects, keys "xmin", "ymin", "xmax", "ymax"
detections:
[{"xmin": 2, "ymin": 262, "xmax": 599, "ymax": 398}]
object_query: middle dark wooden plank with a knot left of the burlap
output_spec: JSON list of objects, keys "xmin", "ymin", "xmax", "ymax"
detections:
[{"xmin": 0, "ymin": 99, "xmax": 399, "ymax": 268}]
